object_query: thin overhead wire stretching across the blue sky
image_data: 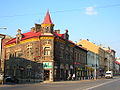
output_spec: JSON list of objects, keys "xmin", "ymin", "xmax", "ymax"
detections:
[{"xmin": 0, "ymin": 4, "xmax": 120, "ymax": 18}]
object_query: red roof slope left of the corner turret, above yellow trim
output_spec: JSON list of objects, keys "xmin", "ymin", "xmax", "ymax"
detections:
[{"xmin": 6, "ymin": 32, "xmax": 41, "ymax": 44}]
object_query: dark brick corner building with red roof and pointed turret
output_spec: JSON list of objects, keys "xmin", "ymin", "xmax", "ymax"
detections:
[{"xmin": 4, "ymin": 12, "xmax": 87, "ymax": 81}]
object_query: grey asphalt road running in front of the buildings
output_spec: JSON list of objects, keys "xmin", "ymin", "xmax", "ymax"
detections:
[{"xmin": 0, "ymin": 77, "xmax": 120, "ymax": 90}]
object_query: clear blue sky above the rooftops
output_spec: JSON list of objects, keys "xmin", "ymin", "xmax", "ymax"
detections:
[{"xmin": 0, "ymin": 0, "xmax": 120, "ymax": 57}]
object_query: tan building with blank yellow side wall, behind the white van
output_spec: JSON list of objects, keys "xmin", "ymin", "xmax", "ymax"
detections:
[{"xmin": 77, "ymin": 40, "xmax": 115, "ymax": 76}]
